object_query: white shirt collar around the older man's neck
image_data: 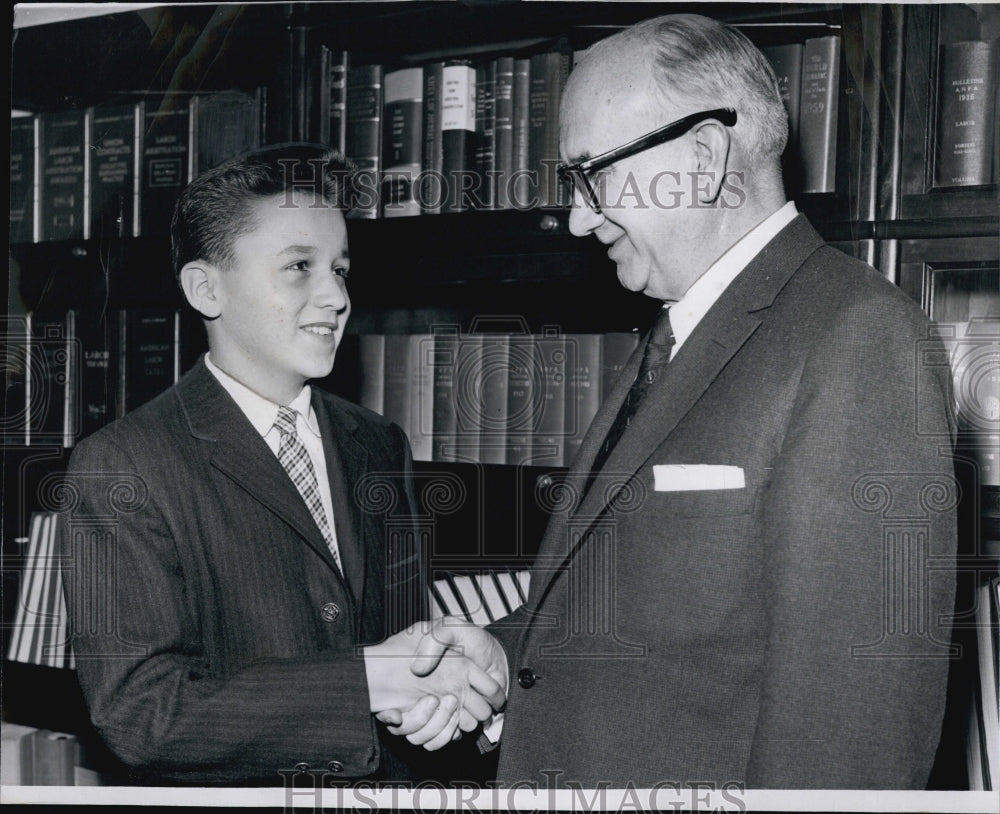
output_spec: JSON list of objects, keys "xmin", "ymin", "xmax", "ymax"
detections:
[{"xmin": 667, "ymin": 201, "xmax": 798, "ymax": 358}]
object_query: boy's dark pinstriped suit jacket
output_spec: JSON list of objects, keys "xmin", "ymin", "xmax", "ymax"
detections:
[{"xmin": 60, "ymin": 361, "xmax": 425, "ymax": 783}]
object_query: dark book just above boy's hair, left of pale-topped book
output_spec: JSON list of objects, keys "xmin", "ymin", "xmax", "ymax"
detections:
[{"xmin": 345, "ymin": 65, "xmax": 383, "ymax": 219}]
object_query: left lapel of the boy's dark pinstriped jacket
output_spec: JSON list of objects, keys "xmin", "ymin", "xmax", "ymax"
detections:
[{"xmin": 178, "ymin": 361, "xmax": 348, "ymax": 571}]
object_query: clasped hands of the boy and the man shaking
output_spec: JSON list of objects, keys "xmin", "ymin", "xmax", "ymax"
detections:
[{"xmin": 364, "ymin": 616, "xmax": 508, "ymax": 751}]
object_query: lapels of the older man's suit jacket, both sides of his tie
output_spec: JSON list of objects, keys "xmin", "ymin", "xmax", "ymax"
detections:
[{"xmin": 532, "ymin": 215, "xmax": 824, "ymax": 606}]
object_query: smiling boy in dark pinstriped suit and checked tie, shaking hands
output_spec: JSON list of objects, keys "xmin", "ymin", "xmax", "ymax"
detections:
[{"xmin": 60, "ymin": 146, "xmax": 503, "ymax": 784}]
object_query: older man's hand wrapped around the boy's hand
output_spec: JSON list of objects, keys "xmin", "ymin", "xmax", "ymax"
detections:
[{"xmin": 377, "ymin": 616, "xmax": 508, "ymax": 750}]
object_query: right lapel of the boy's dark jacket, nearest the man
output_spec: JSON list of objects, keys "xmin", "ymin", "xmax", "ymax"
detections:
[{"xmin": 312, "ymin": 396, "xmax": 370, "ymax": 608}]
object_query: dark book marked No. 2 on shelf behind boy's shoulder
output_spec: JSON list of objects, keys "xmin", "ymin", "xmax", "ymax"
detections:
[{"xmin": 73, "ymin": 310, "xmax": 122, "ymax": 440}]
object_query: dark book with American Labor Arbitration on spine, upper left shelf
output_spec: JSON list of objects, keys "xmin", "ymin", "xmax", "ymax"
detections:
[{"xmin": 38, "ymin": 110, "xmax": 87, "ymax": 241}]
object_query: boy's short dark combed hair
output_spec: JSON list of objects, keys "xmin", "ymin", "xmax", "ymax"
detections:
[{"xmin": 170, "ymin": 144, "xmax": 354, "ymax": 284}]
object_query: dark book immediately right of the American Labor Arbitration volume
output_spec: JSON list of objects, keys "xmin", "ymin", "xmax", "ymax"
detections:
[{"xmin": 84, "ymin": 104, "xmax": 140, "ymax": 239}]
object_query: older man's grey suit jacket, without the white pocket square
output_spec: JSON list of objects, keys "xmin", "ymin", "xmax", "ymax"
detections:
[{"xmin": 495, "ymin": 216, "xmax": 956, "ymax": 789}]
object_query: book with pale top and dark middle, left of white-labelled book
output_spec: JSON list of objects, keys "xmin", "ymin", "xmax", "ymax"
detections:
[{"xmin": 382, "ymin": 68, "xmax": 424, "ymax": 218}]
